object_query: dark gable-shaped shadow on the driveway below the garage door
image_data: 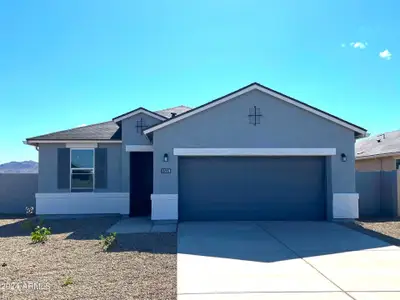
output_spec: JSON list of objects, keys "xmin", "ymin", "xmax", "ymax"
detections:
[{"xmin": 178, "ymin": 221, "xmax": 397, "ymax": 262}]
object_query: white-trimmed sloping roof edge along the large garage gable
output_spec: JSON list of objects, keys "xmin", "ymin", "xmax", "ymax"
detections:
[{"xmin": 144, "ymin": 82, "xmax": 367, "ymax": 136}]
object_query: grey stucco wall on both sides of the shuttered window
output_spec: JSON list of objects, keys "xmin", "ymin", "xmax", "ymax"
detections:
[{"xmin": 38, "ymin": 143, "xmax": 122, "ymax": 193}]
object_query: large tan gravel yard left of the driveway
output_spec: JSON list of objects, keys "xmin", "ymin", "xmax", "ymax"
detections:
[{"xmin": 0, "ymin": 217, "xmax": 176, "ymax": 299}]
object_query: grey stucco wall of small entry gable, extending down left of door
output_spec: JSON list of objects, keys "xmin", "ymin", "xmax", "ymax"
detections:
[{"xmin": 120, "ymin": 114, "xmax": 161, "ymax": 193}]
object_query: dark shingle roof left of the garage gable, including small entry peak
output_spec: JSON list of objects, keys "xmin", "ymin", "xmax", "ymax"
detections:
[{"xmin": 26, "ymin": 105, "xmax": 191, "ymax": 144}]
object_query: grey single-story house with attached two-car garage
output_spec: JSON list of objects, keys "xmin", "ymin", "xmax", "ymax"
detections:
[{"xmin": 27, "ymin": 83, "xmax": 366, "ymax": 221}]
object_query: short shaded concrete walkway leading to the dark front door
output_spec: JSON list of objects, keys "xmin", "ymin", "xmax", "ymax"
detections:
[{"xmin": 107, "ymin": 217, "xmax": 177, "ymax": 234}]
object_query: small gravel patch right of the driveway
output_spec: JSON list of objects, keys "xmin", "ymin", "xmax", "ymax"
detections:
[{"xmin": 344, "ymin": 218, "xmax": 400, "ymax": 246}]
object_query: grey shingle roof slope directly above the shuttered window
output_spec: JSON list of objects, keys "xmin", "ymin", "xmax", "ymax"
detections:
[{"xmin": 26, "ymin": 121, "xmax": 121, "ymax": 144}]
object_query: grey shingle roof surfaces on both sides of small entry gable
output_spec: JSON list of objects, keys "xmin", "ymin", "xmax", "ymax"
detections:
[{"xmin": 27, "ymin": 105, "xmax": 191, "ymax": 142}]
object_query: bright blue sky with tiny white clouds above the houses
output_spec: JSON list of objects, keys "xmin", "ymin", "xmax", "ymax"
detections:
[{"xmin": 0, "ymin": 0, "xmax": 400, "ymax": 163}]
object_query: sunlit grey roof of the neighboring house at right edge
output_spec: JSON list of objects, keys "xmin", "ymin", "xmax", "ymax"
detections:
[{"xmin": 356, "ymin": 130, "xmax": 400, "ymax": 159}]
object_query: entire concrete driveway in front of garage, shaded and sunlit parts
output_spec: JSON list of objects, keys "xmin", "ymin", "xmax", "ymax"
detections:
[{"xmin": 178, "ymin": 222, "xmax": 400, "ymax": 300}]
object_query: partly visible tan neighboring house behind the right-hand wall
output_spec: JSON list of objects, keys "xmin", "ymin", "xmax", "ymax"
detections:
[{"xmin": 356, "ymin": 130, "xmax": 400, "ymax": 171}]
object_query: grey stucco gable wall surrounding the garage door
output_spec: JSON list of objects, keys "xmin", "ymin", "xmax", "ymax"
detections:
[{"xmin": 153, "ymin": 91, "xmax": 355, "ymax": 202}]
